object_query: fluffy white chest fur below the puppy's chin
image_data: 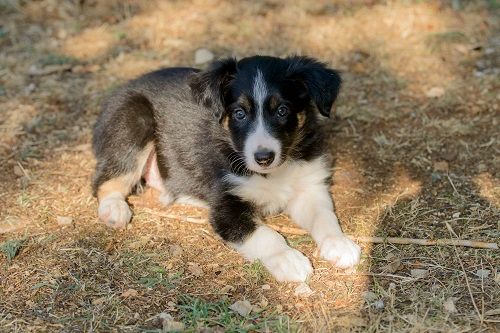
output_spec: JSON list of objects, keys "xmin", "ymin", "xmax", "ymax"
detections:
[{"xmin": 229, "ymin": 158, "xmax": 330, "ymax": 214}]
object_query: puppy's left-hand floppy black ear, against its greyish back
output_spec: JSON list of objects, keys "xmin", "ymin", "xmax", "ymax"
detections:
[{"xmin": 189, "ymin": 58, "xmax": 237, "ymax": 121}]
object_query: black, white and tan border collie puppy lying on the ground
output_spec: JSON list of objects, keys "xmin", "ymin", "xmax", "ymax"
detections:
[{"xmin": 93, "ymin": 56, "xmax": 360, "ymax": 281}]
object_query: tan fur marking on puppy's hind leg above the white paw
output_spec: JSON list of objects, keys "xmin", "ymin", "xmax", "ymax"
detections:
[{"xmin": 97, "ymin": 142, "xmax": 154, "ymax": 201}]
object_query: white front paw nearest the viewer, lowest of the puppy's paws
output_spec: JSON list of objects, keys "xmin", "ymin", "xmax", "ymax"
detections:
[{"xmin": 261, "ymin": 248, "xmax": 313, "ymax": 282}]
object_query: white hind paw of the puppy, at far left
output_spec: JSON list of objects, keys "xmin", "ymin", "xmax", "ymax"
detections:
[{"xmin": 97, "ymin": 198, "xmax": 132, "ymax": 229}]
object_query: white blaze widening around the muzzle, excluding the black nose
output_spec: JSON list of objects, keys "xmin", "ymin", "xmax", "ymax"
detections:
[{"xmin": 243, "ymin": 70, "xmax": 281, "ymax": 173}]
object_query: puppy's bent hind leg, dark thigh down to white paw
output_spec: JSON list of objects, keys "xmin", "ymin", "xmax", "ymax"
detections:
[{"xmin": 93, "ymin": 93, "xmax": 154, "ymax": 228}]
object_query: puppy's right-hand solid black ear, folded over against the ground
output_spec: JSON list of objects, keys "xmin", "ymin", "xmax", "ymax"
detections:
[{"xmin": 286, "ymin": 56, "xmax": 342, "ymax": 117}]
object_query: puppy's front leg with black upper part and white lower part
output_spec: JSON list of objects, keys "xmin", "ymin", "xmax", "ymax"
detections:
[{"xmin": 210, "ymin": 194, "xmax": 313, "ymax": 281}]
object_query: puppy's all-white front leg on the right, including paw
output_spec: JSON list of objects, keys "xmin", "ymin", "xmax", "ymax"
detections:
[{"xmin": 287, "ymin": 184, "xmax": 361, "ymax": 268}]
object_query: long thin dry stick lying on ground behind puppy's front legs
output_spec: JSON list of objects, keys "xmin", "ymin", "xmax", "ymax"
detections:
[{"xmin": 144, "ymin": 208, "xmax": 498, "ymax": 250}]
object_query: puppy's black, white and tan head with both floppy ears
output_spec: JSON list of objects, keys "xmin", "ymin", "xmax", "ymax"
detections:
[{"xmin": 190, "ymin": 56, "xmax": 341, "ymax": 173}]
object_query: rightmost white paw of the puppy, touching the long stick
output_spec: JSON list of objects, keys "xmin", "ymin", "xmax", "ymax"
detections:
[{"xmin": 320, "ymin": 235, "xmax": 361, "ymax": 268}]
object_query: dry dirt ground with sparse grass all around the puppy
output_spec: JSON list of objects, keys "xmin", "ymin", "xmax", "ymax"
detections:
[{"xmin": 0, "ymin": 0, "xmax": 500, "ymax": 332}]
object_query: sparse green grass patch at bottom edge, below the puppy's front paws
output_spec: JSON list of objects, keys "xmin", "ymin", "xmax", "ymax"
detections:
[{"xmin": 177, "ymin": 295, "xmax": 297, "ymax": 332}]
